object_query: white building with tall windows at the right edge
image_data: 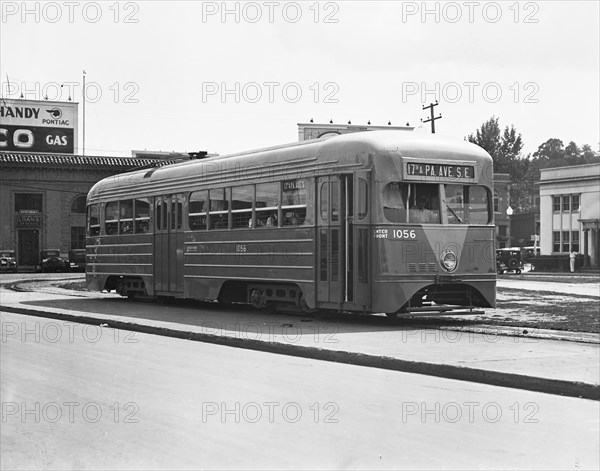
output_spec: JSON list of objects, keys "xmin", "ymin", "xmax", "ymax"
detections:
[{"xmin": 540, "ymin": 163, "xmax": 600, "ymax": 267}]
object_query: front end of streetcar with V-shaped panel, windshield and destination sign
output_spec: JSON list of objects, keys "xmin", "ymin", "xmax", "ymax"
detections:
[{"xmin": 372, "ymin": 141, "xmax": 496, "ymax": 314}]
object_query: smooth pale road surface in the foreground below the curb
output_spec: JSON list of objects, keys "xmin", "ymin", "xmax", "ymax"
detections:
[{"xmin": 0, "ymin": 314, "xmax": 600, "ymax": 469}]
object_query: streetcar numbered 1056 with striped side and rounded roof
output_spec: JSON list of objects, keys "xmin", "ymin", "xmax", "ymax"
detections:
[{"xmin": 86, "ymin": 130, "xmax": 496, "ymax": 316}]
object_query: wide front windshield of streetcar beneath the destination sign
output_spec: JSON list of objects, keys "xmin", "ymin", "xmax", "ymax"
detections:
[{"xmin": 382, "ymin": 182, "xmax": 491, "ymax": 224}]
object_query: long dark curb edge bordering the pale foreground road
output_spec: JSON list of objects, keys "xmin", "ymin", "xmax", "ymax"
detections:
[{"xmin": 0, "ymin": 306, "xmax": 600, "ymax": 401}]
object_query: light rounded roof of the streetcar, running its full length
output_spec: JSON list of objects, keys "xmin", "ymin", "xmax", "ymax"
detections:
[{"xmin": 89, "ymin": 130, "xmax": 492, "ymax": 201}]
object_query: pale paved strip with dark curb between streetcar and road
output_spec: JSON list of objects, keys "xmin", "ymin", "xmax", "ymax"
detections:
[{"xmin": 0, "ymin": 288, "xmax": 600, "ymax": 400}]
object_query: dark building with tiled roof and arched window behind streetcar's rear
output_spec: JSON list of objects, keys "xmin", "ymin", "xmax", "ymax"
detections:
[{"xmin": 0, "ymin": 152, "xmax": 176, "ymax": 270}]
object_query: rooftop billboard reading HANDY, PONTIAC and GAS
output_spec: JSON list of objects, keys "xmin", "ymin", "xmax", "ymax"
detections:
[{"xmin": 0, "ymin": 98, "xmax": 78, "ymax": 154}]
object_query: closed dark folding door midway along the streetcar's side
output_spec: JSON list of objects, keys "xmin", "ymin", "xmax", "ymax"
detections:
[{"xmin": 154, "ymin": 194, "xmax": 184, "ymax": 296}]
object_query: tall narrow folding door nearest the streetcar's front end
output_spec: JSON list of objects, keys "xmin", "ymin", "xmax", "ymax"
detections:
[{"xmin": 316, "ymin": 175, "xmax": 355, "ymax": 309}]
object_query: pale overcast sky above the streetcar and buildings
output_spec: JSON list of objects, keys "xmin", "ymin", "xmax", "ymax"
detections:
[{"xmin": 0, "ymin": 0, "xmax": 600, "ymax": 156}]
